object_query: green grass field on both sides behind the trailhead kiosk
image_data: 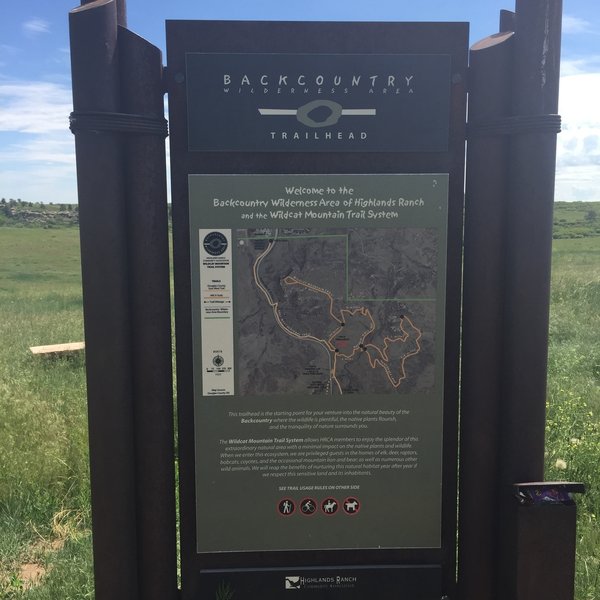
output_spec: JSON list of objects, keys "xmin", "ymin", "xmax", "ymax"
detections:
[{"xmin": 0, "ymin": 224, "xmax": 600, "ymax": 600}]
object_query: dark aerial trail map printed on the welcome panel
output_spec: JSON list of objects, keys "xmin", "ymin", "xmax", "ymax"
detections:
[{"xmin": 234, "ymin": 227, "xmax": 438, "ymax": 396}]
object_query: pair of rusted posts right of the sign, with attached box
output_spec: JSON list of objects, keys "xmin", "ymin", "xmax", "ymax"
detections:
[{"xmin": 459, "ymin": 0, "xmax": 582, "ymax": 600}]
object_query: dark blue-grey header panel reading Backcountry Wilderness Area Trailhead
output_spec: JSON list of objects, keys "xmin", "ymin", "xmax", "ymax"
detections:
[{"xmin": 186, "ymin": 53, "xmax": 451, "ymax": 152}]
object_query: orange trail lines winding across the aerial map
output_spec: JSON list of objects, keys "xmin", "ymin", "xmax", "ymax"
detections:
[{"xmin": 253, "ymin": 241, "xmax": 422, "ymax": 394}]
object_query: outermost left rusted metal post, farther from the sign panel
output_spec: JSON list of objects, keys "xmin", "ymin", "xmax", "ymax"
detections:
[{"xmin": 69, "ymin": 0, "xmax": 138, "ymax": 600}]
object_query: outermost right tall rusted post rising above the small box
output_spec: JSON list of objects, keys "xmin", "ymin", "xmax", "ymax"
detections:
[{"xmin": 502, "ymin": 0, "xmax": 562, "ymax": 506}]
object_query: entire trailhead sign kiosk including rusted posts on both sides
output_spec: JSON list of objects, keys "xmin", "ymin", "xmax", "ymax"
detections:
[{"xmin": 70, "ymin": 0, "xmax": 580, "ymax": 600}]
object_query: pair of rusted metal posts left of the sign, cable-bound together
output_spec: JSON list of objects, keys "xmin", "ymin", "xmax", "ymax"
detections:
[{"xmin": 69, "ymin": 0, "xmax": 178, "ymax": 600}]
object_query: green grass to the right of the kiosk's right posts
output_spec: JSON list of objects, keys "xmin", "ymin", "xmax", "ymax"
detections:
[{"xmin": 546, "ymin": 237, "xmax": 600, "ymax": 600}]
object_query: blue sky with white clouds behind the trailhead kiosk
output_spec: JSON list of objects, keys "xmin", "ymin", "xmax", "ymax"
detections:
[{"xmin": 0, "ymin": 0, "xmax": 600, "ymax": 203}]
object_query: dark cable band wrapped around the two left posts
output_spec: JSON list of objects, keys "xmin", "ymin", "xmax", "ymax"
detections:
[{"xmin": 69, "ymin": 112, "xmax": 169, "ymax": 137}]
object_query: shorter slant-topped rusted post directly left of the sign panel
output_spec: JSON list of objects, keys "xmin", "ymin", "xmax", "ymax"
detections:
[{"xmin": 119, "ymin": 29, "xmax": 178, "ymax": 600}]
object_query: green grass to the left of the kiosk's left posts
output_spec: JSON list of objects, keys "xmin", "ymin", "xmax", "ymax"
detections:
[{"xmin": 0, "ymin": 228, "xmax": 91, "ymax": 599}]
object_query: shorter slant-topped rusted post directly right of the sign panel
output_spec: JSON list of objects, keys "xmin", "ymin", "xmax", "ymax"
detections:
[{"xmin": 458, "ymin": 33, "xmax": 514, "ymax": 600}]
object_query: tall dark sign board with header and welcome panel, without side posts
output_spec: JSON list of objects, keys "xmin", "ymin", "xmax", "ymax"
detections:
[{"xmin": 167, "ymin": 21, "xmax": 468, "ymax": 598}]
